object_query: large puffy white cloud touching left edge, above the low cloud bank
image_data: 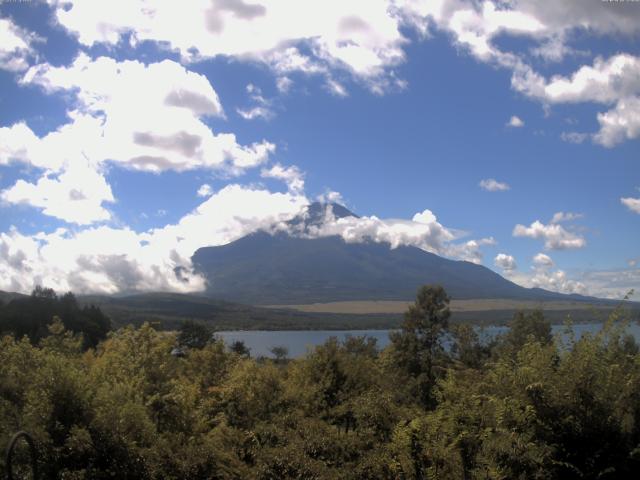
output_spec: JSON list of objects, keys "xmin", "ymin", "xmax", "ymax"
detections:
[{"xmin": 0, "ymin": 54, "xmax": 275, "ymax": 224}]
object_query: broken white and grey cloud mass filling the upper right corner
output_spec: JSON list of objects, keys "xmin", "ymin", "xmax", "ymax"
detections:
[{"xmin": 396, "ymin": 0, "xmax": 640, "ymax": 147}]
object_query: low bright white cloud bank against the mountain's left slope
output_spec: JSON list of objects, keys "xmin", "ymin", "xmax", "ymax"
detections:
[{"xmin": 0, "ymin": 185, "xmax": 307, "ymax": 294}]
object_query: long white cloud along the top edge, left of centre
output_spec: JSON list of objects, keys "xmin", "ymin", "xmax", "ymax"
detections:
[{"xmin": 51, "ymin": 0, "xmax": 406, "ymax": 94}]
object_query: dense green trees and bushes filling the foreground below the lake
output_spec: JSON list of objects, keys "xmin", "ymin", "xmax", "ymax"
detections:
[{"xmin": 0, "ymin": 287, "xmax": 640, "ymax": 480}]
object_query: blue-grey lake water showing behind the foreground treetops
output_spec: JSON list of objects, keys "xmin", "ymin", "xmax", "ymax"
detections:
[{"xmin": 216, "ymin": 323, "xmax": 640, "ymax": 357}]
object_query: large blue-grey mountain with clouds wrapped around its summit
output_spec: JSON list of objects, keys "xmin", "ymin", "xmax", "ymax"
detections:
[{"xmin": 192, "ymin": 203, "xmax": 587, "ymax": 305}]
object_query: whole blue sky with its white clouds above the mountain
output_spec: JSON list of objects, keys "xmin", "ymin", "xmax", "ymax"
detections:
[{"xmin": 0, "ymin": 0, "xmax": 640, "ymax": 298}]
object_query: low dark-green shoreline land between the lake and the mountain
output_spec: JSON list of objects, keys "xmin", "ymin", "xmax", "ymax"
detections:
[{"xmin": 78, "ymin": 292, "xmax": 640, "ymax": 331}]
